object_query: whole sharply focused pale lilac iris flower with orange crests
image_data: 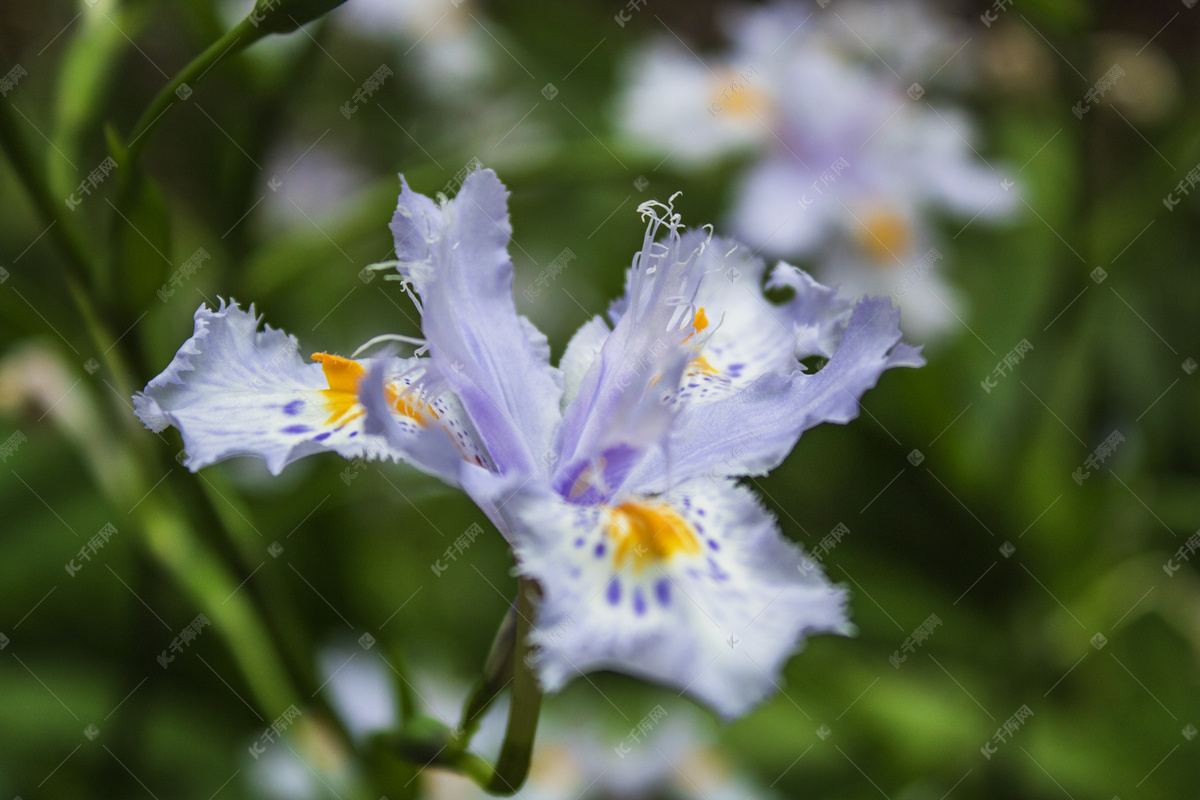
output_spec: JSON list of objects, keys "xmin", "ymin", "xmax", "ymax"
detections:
[{"xmin": 134, "ymin": 169, "xmax": 923, "ymax": 717}]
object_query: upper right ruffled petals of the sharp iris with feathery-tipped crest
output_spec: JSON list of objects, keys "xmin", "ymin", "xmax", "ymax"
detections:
[{"xmin": 552, "ymin": 196, "xmax": 923, "ymax": 503}]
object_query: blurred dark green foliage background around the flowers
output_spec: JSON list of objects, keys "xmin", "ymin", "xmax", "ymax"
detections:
[{"xmin": 0, "ymin": 0, "xmax": 1200, "ymax": 800}]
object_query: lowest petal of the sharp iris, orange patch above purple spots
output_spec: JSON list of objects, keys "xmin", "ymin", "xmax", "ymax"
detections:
[{"xmin": 510, "ymin": 479, "xmax": 850, "ymax": 717}]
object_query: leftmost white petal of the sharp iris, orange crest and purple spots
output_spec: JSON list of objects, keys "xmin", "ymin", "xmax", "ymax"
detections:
[{"xmin": 133, "ymin": 301, "xmax": 475, "ymax": 475}]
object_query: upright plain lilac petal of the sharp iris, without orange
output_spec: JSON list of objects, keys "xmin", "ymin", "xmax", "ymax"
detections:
[{"xmin": 391, "ymin": 169, "xmax": 563, "ymax": 471}]
